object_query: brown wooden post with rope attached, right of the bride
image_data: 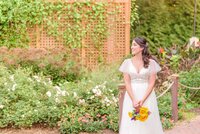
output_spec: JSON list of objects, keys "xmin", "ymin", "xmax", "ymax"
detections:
[{"xmin": 171, "ymin": 74, "xmax": 178, "ymax": 122}]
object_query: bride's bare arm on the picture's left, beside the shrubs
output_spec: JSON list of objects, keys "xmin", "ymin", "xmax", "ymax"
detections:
[{"xmin": 123, "ymin": 73, "xmax": 138, "ymax": 108}]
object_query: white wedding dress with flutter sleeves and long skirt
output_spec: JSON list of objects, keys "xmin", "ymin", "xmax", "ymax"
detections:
[{"xmin": 119, "ymin": 59, "xmax": 164, "ymax": 134}]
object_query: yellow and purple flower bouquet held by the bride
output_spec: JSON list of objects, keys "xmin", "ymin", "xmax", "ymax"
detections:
[{"xmin": 128, "ymin": 107, "xmax": 151, "ymax": 122}]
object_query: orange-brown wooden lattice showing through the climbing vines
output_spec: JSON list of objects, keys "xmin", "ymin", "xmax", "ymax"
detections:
[{"xmin": 28, "ymin": 0, "xmax": 131, "ymax": 69}]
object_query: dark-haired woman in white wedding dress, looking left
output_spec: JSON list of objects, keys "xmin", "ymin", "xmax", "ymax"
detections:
[{"xmin": 119, "ymin": 37, "xmax": 164, "ymax": 134}]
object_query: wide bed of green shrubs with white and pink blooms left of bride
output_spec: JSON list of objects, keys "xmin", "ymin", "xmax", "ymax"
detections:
[{"xmin": 0, "ymin": 65, "xmax": 121, "ymax": 133}]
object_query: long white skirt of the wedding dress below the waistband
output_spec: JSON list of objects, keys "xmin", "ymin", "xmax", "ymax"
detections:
[{"xmin": 119, "ymin": 81, "xmax": 164, "ymax": 134}]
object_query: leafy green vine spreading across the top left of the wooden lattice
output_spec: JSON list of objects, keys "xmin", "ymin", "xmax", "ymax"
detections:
[{"xmin": 0, "ymin": 0, "xmax": 114, "ymax": 48}]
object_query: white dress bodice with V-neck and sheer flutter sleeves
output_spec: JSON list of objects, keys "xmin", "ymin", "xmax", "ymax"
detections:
[{"xmin": 119, "ymin": 59, "xmax": 161, "ymax": 82}]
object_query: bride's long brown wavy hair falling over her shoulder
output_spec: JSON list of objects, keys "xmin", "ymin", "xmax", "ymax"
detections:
[{"xmin": 133, "ymin": 37, "xmax": 154, "ymax": 68}]
